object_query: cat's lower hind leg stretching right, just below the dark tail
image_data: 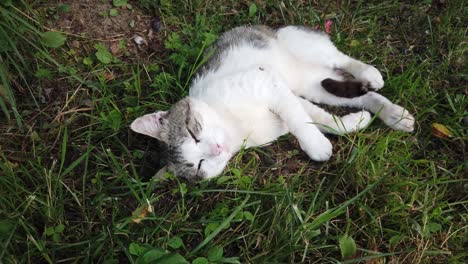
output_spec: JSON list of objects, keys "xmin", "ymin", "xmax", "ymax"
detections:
[{"xmin": 302, "ymin": 90, "xmax": 414, "ymax": 132}]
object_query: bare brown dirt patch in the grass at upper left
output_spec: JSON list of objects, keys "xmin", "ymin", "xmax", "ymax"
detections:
[{"xmin": 50, "ymin": 0, "xmax": 164, "ymax": 61}]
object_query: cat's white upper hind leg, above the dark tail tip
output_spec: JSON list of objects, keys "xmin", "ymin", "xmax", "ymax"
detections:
[{"xmin": 277, "ymin": 26, "xmax": 384, "ymax": 90}]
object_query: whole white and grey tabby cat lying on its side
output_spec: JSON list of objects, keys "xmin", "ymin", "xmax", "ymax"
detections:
[{"xmin": 131, "ymin": 26, "xmax": 415, "ymax": 180}]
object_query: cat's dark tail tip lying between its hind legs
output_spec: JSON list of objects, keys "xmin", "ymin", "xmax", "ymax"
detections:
[{"xmin": 321, "ymin": 78, "xmax": 370, "ymax": 98}]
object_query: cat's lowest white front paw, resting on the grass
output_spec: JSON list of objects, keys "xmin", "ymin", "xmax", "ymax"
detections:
[{"xmin": 299, "ymin": 133, "xmax": 333, "ymax": 161}]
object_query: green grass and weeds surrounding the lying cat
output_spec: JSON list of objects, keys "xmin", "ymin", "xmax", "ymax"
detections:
[{"xmin": 0, "ymin": 0, "xmax": 468, "ymax": 263}]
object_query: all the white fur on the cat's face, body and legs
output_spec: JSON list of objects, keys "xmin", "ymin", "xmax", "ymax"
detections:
[{"xmin": 132, "ymin": 27, "xmax": 414, "ymax": 178}]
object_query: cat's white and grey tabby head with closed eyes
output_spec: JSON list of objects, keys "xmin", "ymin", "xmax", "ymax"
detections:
[{"xmin": 131, "ymin": 97, "xmax": 232, "ymax": 180}]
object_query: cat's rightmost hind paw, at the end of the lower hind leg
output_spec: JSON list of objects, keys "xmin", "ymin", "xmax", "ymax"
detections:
[{"xmin": 381, "ymin": 104, "xmax": 414, "ymax": 132}]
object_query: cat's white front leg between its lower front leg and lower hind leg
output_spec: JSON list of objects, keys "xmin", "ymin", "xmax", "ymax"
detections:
[{"xmin": 299, "ymin": 97, "xmax": 371, "ymax": 135}]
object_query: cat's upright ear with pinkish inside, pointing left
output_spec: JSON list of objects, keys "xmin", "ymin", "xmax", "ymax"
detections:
[{"xmin": 130, "ymin": 111, "xmax": 168, "ymax": 141}]
